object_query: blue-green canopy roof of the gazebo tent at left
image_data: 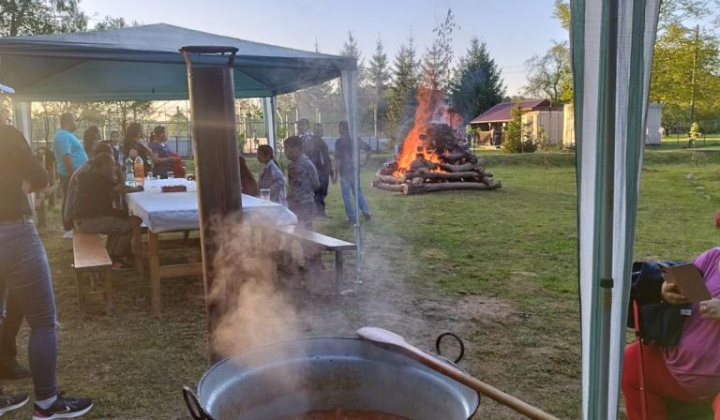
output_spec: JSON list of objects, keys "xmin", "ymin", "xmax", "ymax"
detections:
[{"xmin": 0, "ymin": 23, "xmax": 356, "ymax": 101}]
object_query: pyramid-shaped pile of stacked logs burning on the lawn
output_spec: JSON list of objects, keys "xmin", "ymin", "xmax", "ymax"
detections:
[{"xmin": 372, "ymin": 124, "xmax": 502, "ymax": 195}]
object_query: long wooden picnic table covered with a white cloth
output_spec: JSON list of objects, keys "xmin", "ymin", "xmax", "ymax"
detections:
[{"xmin": 125, "ymin": 178, "xmax": 297, "ymax": 313}]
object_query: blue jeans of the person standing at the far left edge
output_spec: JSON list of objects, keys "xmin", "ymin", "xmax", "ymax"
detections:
[{"xmin": 0, "ymin": 221, "xmax": 57, "ymax": 400}]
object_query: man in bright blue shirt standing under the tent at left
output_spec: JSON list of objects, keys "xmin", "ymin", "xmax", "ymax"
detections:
[{"xmin": 53, "ymin": 113, "xmax": 88, "ymax": 239}]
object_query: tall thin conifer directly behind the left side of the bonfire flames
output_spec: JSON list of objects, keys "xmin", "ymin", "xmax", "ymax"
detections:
[{"xmin": 387, "ymin": 36, "xmax": 420, "ymax": 142}]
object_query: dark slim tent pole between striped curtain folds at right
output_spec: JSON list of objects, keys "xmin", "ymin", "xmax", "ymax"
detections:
[{"xmin": 597, "ymin": 0, "xmax": 618, "ymax": 419}]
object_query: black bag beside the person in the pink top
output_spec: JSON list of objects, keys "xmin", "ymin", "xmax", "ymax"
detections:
[{"xmin": 627, "ymin": 261, "xmax": 691, "ymax": 348}]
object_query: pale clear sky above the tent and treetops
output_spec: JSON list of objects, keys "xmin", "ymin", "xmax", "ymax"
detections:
[{"xmin": 80, "ymin": 0, "xmax": 567, "ymax": 95}]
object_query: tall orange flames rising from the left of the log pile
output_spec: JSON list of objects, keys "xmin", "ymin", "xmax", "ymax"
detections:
[{"xmin": 393, "ymin": 87, "xmax": 462, "ymax": 177}]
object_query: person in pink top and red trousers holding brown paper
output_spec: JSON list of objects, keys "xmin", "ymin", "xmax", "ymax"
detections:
[{"xmin": 622, "ymin": 248, "xmax": 720, "ymax": 420}]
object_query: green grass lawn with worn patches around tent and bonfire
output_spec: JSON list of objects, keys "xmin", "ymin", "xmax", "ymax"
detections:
[{"xmin": 3, "ymin": 150, "xmax": 720, "ymax": 419}]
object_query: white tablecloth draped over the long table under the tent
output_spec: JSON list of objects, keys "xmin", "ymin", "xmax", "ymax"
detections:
[{"xmin": 125, "ymin": 178, "xmax": 297, "ymax": 233}]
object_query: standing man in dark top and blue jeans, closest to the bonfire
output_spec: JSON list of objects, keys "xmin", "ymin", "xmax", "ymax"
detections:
[{"xmin": 333, "ymin": 121, "xmax": 372, "ymax": 223}]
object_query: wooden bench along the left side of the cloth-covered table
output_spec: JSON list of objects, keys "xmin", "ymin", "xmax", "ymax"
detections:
[{"xmin": 73, "ymin": 231, "xmax": 112, "ymax": 316}]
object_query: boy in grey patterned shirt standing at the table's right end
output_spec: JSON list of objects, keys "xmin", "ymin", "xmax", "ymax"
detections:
[{"xmin": 283, "ymin": 136, "xmax": 320, "ymax": 229}]
